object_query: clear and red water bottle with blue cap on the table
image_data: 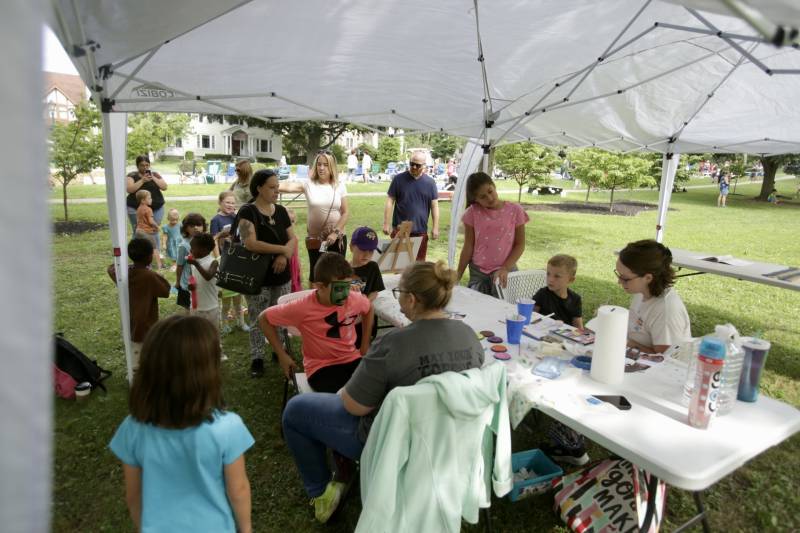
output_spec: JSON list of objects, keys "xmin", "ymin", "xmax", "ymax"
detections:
[{"xmin": 689, "ymin": 335, "xmax": 725, "ymax": 429}]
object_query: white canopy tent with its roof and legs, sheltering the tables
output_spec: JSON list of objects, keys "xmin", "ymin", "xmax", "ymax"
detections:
[{"xmin": 0, "ymin": 0, "xmax": 800, "ymax": 532}]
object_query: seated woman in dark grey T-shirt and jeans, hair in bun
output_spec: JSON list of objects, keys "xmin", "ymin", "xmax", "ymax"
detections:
[{"xmin": 283, "ymin": 261, "xmax": 483, "ymax": 522}]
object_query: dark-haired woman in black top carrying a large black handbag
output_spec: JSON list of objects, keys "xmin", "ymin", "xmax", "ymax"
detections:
[{"xmin": 237, "ymin": 170, "xmax": 297, "ymax": 377}]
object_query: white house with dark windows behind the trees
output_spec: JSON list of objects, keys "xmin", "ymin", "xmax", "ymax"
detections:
[{"xmin": 162, "ymin": 114, "xmax": 283, "ymax": 161}]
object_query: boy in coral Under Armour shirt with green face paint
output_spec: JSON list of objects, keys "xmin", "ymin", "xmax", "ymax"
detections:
[{"xmin": 258, "ymin": 252, "xmax": 373, "ymax": 392}]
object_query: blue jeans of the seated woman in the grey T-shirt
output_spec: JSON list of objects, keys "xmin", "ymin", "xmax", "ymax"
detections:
[{"xmin": 283, "ymin": 392, "xmax": 364, "ymax": 498}]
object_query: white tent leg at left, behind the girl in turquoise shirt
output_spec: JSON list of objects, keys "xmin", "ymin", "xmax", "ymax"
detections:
[{"xmin": 102, "ymin": 112, "xmax": 133, "ymax": 383}]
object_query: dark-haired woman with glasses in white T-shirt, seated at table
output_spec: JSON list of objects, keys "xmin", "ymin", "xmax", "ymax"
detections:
[{"xmin": 614, "ymin": 240, "xmax": 692, "ymax": 353}]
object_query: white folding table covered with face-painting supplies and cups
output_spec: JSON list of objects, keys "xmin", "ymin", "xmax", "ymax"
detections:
[{"xmin": 376, "ymin": 278, "xmax": 800, "ymax": 525}]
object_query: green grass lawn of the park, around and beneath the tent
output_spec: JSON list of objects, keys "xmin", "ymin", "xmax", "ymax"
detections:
[{"xmin": 51, "ymin": 181, "xmax": 800, "ymax": 532}]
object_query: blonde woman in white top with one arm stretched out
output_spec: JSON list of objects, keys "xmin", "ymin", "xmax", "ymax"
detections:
[{"xmin": 280, "ymin": 150, "xmax": 349, "ymax": 282}]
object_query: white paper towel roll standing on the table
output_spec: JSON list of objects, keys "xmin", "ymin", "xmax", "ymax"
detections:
[{"xmin": 591, "ymin": 305, "xmax": 628, "ymax": 385}]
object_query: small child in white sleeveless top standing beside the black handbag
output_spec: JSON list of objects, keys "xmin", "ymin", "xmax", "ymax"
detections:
[{"xmin": 186, "ymin": 233, "xmax": 228, "ymax": 361}]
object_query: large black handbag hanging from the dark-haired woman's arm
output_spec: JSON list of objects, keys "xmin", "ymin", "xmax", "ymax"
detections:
[{"xmin": 217, "ymin": 208, "xmax": 274, "ymax": 295}]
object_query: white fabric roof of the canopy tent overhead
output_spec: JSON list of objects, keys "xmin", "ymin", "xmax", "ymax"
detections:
[{"xmin": 48, "ymin": 0, "xmax": 800, "ymax": 154}]
